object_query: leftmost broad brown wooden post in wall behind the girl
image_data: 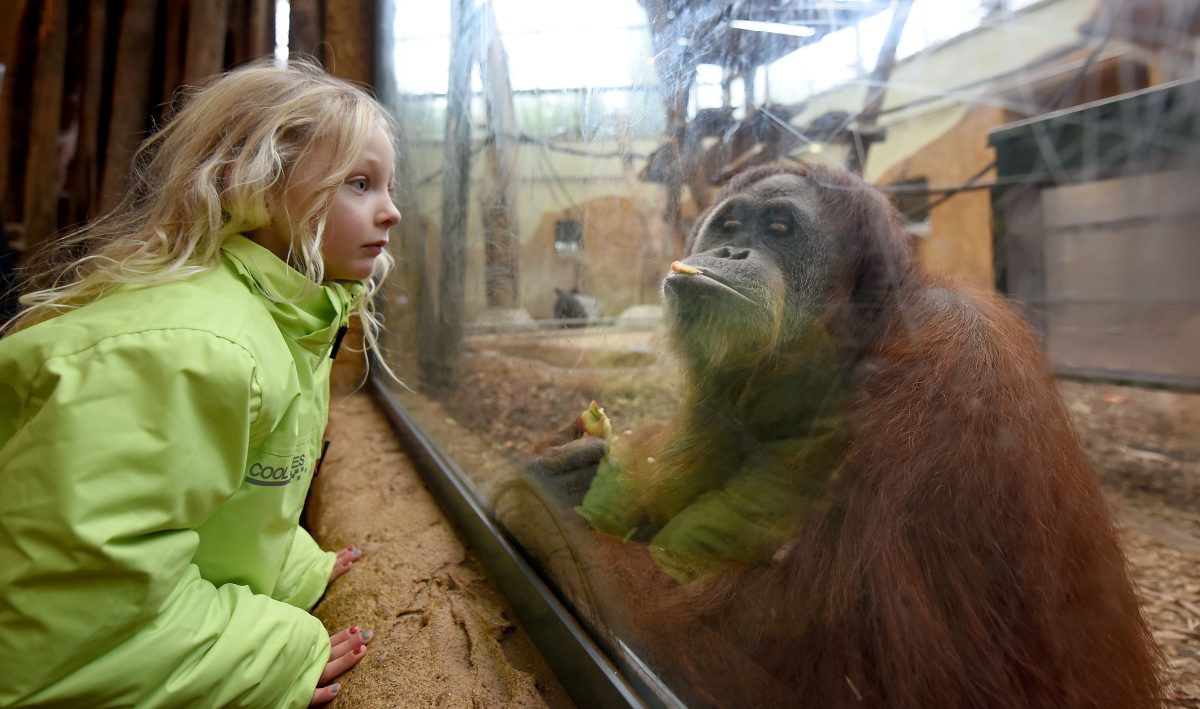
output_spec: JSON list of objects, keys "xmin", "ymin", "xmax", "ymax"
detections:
[{"xmin": 24, "ymin": 0, "xmax": 67, "ymax": 247}]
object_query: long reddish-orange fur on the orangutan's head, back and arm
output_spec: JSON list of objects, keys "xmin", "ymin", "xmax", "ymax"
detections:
[{"xmin": 590, "ymin": 167, "xmax": 1162, "ymax": 709}]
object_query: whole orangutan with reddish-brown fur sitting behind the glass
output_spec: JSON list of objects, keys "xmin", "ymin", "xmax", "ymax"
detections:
[{"xmin": 532, "ymin": 160, "xmax": 1162, "ymax": 709}]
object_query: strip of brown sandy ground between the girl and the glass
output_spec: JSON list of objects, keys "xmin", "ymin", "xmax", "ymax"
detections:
[{"xmin": 308, "ymin": 393, "xmax": 572, "ymax": 709}]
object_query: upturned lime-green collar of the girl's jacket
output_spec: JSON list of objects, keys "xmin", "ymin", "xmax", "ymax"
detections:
[{"xmin": 221, "ymin": 234, "xmax": 366, "ymax": 353}]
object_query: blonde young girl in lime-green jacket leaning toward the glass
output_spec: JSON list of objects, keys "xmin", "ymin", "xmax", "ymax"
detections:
[{"xmin": 0, "ymin": 58, "xmax": 400, "ymax": 707}]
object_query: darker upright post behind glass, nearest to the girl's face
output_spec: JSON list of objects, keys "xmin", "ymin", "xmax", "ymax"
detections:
[{"xmin": 421, "ymin": 0, "xmax": 479, "ymax": 391}]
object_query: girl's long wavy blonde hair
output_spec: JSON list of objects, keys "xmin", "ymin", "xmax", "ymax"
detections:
[{"xmin": 10, "ymin": 60, "xmax": 395, "ymax": 371}]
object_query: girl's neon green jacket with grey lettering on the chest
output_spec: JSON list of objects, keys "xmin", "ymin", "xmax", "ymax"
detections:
[{"xmin": 0, "ymin": 236, "xmax": 361, "ymax": 708}]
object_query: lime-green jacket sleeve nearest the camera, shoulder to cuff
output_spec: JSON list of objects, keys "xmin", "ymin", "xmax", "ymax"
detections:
[{"xmin": 0, "ymin": 330, "xmax": 329, "ymax": 707}]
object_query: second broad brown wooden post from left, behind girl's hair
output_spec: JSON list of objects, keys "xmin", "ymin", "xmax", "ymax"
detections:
[{"xmin": 100, "ymin": 2, "xmax": 158, "ymax": 212}]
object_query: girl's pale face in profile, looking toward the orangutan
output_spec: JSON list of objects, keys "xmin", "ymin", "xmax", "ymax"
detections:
[{"xmin": 247, "ymin": 126, "xmax": 400, "ymax": 281}]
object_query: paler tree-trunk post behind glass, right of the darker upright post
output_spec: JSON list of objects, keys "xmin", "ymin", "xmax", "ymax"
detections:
[{"xmin": 479, "ymin": 2, "xmax": 520, "ymax": 308}]
